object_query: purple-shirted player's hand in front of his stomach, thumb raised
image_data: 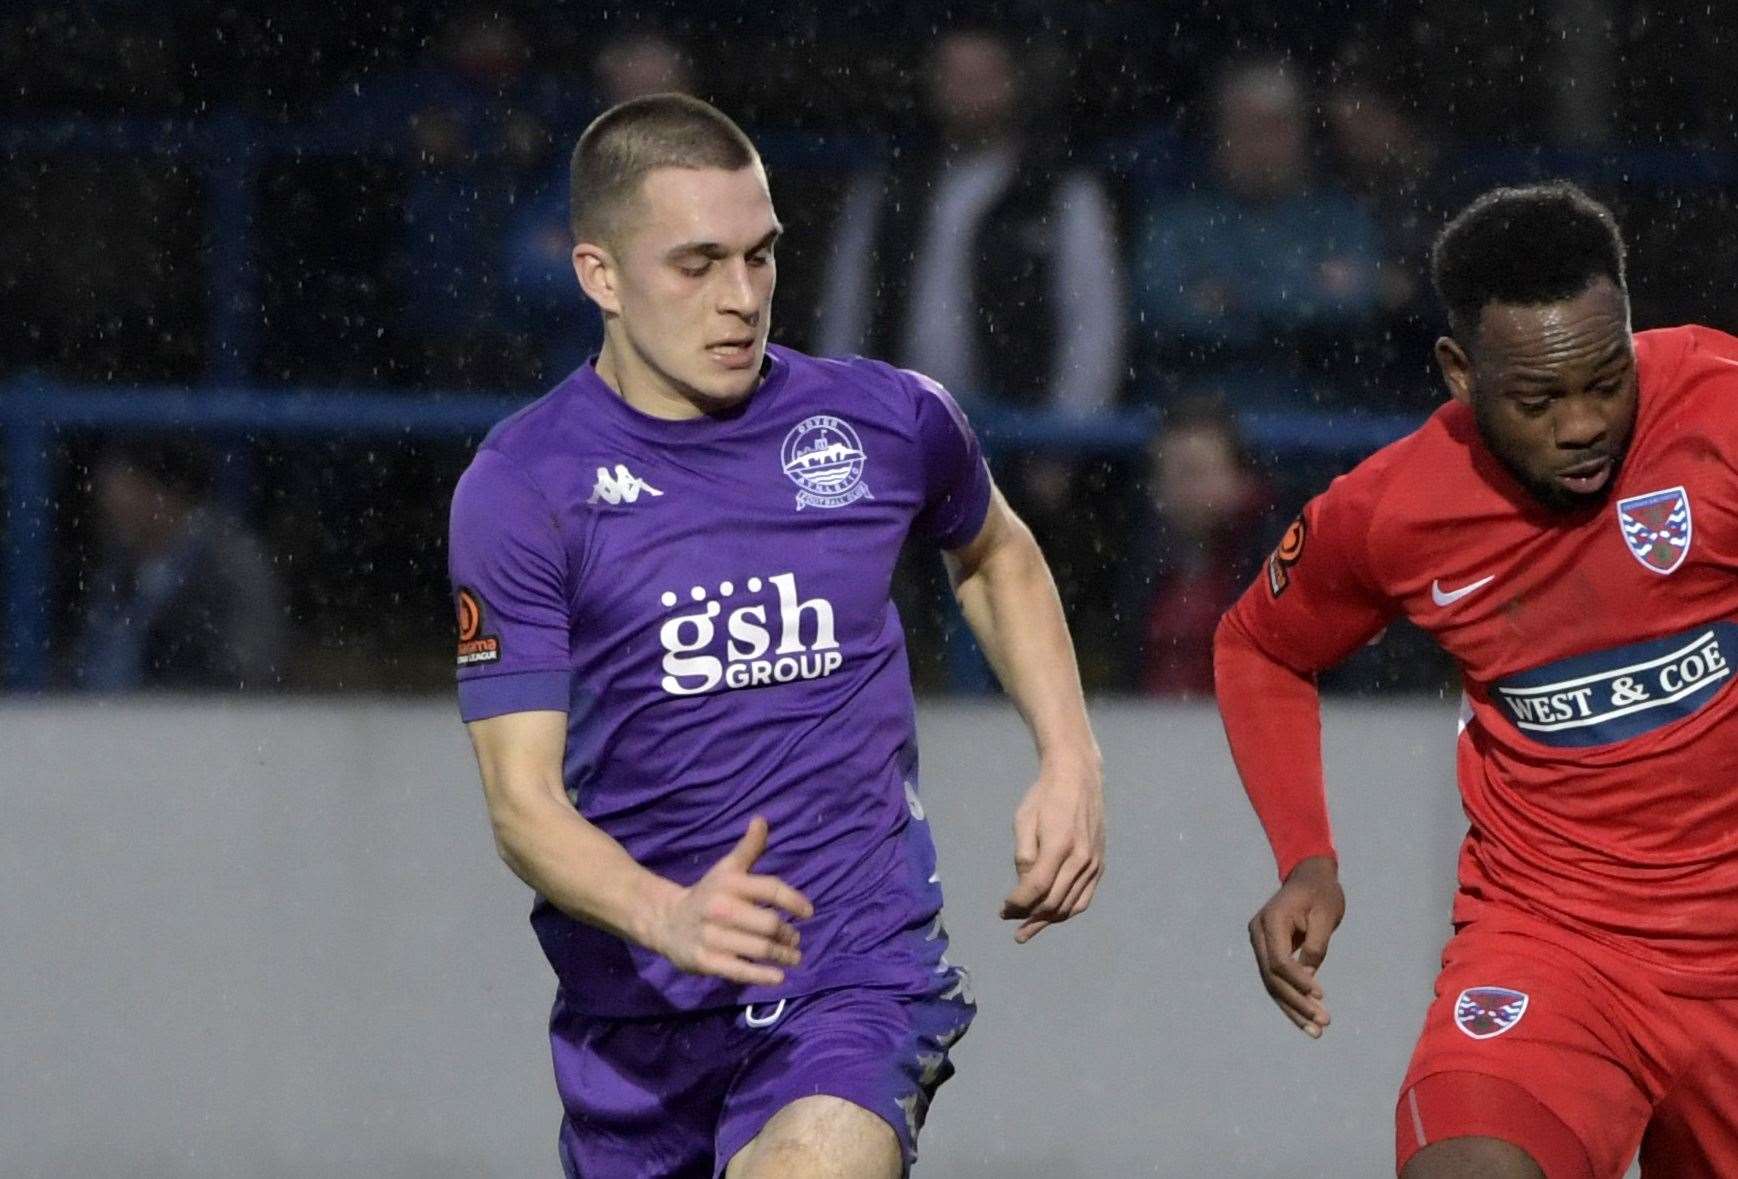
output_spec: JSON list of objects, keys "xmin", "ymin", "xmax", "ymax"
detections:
[{"xmin": 647, "ymin": 816, "xmax": 815, "ymax": 986}]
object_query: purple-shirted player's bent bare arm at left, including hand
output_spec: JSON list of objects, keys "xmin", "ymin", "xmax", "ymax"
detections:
[{"xmin": 468, "ymin": 711, "xmax": 813, "ymax": 986}]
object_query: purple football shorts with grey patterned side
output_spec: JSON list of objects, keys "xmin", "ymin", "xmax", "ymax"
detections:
[{"xmin": 549, "ymin": 967, "xmax": 977, "ymax": 1179}]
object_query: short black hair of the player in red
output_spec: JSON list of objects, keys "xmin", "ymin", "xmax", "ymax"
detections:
[{"xmin": 1430, "ymin": 181, "xmax": 1627, "ymax": 343}]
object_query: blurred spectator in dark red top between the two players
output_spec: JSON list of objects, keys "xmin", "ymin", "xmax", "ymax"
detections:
[{"xmin": 1116, "ymin": 396, "xmax": 1276, "ymax": 699}]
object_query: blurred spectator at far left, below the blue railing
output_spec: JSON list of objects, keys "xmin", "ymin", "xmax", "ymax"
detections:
[{"xmin": 71, "ymin": 442, "xmax": 283, "ymax": 692}]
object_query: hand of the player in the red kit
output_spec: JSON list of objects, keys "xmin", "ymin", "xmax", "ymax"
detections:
[{"xmin": 1250, "ymin": 856, "xmax": 1345, "ymax": 1040}]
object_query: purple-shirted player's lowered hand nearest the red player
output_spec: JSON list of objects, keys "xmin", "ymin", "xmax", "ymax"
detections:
[{"xmin": 1001, "ymin": 756, "xmax": 1104, "ymax": 943}]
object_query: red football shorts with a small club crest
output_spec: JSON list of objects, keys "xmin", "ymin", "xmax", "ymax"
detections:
[{"xmin": 1394, "ymin": 909, "xmax": 1738, "ymax": 1179}]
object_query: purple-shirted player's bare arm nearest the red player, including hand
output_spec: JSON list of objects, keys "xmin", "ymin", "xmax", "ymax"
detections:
[{"xmin": 947, "ymin": 490, "xmax": 1104, "ymax": 943}]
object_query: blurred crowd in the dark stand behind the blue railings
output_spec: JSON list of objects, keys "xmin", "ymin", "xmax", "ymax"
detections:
[{"xmin": 0, "ymin": 0, "xmax": 1738, "ymax": 697}]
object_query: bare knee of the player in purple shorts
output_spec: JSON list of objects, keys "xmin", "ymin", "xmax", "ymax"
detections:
[{"xmin": 725, "ymin": 1096, "xmax": 905, "ymax": 1179}]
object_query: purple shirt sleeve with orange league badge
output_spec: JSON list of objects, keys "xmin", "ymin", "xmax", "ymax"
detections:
[{"xmin": 447, "ymin": 449, "xmax": 572, "ymax": 722}]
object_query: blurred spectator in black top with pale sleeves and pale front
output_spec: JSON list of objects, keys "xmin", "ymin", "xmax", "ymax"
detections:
[{"xmin": 819, "ymin": 30, "xmax": 1123, "ymax": 412}]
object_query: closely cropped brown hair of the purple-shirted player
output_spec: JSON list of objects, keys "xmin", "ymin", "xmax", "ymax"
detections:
[{"xmin": 568, "ymin": 94, "xmax": 760, "ymax": 242}]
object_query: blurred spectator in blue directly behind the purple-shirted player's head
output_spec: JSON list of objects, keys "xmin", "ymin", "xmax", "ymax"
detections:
[{"xmin": 502, "ymin": 31, "xmax": 695, "ymax": 384}]
